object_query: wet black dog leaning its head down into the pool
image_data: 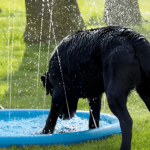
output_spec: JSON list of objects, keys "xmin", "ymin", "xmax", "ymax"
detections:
[{"xmin": 41, "ymin": 26, "xmax": 150, "ymax": 150}]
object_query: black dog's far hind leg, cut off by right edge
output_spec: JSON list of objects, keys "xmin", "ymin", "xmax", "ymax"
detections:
[{"xmin": 136, "ymin": 77, "xmax": 150, "ymax": 111}]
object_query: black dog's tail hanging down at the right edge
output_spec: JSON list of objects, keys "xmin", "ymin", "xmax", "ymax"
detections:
[{"xmin": 132, "ymin": 34, "xmax": 150, "ymax": 75}]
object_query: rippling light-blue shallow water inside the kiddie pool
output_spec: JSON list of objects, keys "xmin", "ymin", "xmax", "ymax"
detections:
[{"xmin": 0, "ymin": 115, "xmax": 117, "ymax": 136}]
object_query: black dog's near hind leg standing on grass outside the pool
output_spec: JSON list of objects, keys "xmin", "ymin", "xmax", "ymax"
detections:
[{"xmin": 106, "ymin": 80, "xmax": 132, "ymax": 150}]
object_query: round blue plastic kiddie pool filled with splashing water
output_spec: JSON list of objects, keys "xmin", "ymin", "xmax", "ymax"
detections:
[{"xmin": 0, "ymin": 109, "xmax": 121, "ymax": 148}]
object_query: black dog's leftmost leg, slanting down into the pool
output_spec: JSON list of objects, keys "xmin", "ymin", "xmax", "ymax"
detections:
[{"xmin": 41, "ymin": 86, "xmax": 66, "ymax": 134}]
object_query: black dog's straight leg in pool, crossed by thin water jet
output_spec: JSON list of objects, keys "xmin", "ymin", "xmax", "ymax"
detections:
[{"xmin": 88, "ymin": 96, "xmax": 101, "ymax": 129}]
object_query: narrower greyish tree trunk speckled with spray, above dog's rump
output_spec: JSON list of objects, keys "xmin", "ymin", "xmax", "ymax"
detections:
[{"xmin": 104, "ymin": 0, "xmax": 141, "ymax": 25}]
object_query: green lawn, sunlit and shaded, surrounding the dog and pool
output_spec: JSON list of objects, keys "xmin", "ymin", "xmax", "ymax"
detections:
[{"xmin": 0, "ymin": 0, "xmax": 150, "ymax": 150}]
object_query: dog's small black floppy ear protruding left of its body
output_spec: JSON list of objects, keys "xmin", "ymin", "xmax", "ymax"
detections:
[{"xmin": 41, "ymin": 72, "xmax": 53, "ymax": 95}]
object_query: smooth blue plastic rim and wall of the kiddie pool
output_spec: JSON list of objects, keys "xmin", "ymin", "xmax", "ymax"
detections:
[{"xmin": 0, "ymin": 109, "xmax": 121, "ymax": 148}]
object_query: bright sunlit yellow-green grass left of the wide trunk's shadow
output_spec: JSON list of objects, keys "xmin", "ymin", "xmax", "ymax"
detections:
[{"xmin": 0, "ymin": 0, "xmax": 26, "ymax": 101}]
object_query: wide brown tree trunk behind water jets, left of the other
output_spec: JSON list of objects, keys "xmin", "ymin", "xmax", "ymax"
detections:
[{"xmin": 23, "ymin": 0, "xmax": 85, "ymax": 43}]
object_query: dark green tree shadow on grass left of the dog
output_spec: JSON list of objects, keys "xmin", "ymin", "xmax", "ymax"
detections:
[{"xmin": 1, "ymin": 44, "xmax": 55, "ymax": 108}]
